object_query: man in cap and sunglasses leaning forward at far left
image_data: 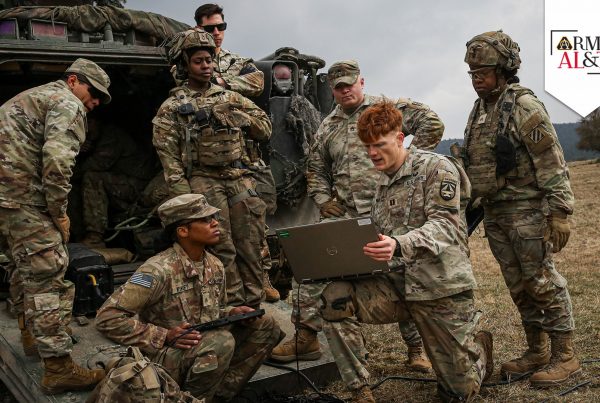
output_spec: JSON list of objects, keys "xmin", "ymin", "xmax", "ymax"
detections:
[{"xmin": 0, "ymin": 59, "xmax": 111, "ymax": 394}]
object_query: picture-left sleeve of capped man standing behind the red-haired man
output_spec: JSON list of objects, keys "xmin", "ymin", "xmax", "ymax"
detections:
[{"xmin": 306, "ymin": 121, "xmax": 333, "ymax": 205}]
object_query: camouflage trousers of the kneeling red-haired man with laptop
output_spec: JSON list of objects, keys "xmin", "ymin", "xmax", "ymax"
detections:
[{"xmin": 321, "ymin": 276, "xmax": 485, "ymax": 399}]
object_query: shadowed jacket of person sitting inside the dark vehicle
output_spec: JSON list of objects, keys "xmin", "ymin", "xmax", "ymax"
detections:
[{"xmin": 81, "ymin": 124, "xmax": 156, "ymax": 180}]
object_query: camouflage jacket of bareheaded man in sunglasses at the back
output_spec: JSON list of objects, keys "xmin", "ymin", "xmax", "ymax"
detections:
[{"xmin": 214, "ymin": 48, "xmax": 265, "ymax": 97}]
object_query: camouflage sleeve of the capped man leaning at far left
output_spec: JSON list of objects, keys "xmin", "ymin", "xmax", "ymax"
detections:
[{"xmin": 42, "ymin": 97, "xmax": 85, "ymax": 217}]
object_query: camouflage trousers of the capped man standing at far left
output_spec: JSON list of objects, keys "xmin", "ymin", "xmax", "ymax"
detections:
[{"xmin": 0, "ymin": 205, "xmax": 75, "ymax": 358}]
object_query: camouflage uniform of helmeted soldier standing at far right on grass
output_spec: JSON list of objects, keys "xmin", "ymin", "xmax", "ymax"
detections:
[{"xmin": 465, "ymin": 84, "xmax": 574, "ymax": 332}]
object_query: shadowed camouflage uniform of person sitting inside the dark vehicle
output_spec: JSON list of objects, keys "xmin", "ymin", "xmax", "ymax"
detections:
[{"xmin": 82, "ymin": 124, "xmax": 155, "ymax": 234}]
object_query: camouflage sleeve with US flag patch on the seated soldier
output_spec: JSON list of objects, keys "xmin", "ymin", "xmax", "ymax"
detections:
[{"xmin": 96, "ymin": 265, "xmax": 168, "ymax": 353}]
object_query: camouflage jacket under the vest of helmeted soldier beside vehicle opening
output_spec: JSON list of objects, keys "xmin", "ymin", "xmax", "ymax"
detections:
[{"xmin": 152, "ymin": 84, "xmax": 271, "ymax": 195}]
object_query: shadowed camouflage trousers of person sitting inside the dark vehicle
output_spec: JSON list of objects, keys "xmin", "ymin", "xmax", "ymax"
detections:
[{"xmin": 82, "ymin": 171, "xmax": 147, "ymax": 234}]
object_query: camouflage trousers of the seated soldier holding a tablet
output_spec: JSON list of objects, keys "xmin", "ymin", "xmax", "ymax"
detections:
[{"xmin": 153, "ymin": 315, "xmax": 282, "ymax": 401}]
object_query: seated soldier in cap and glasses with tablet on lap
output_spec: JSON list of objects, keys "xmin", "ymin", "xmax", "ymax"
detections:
[{"xmin": 96, "ymin": 194, "xmax": 282, "ymax": 401}]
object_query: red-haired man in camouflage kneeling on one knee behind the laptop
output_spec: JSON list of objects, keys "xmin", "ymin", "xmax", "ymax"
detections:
[{"xmin": 321, "ymin": 101, "xmax": 493, "ymax": 402}]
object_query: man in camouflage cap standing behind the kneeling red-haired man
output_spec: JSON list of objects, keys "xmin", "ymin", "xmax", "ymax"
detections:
[{"xmin": 272, "ymin": 60, "xmax": 444, "ymax": 372}]
